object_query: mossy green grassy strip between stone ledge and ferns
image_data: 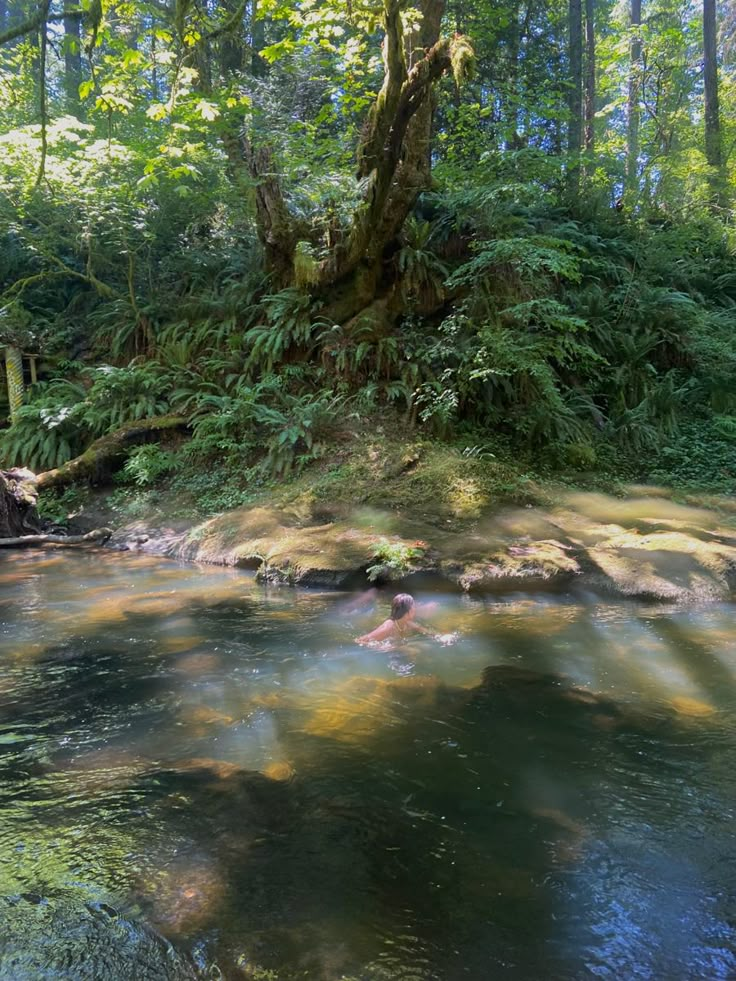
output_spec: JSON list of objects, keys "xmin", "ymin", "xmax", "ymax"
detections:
[{"xmin": 40, "ymin": 408, "xmax": 736, "ymax": 531}]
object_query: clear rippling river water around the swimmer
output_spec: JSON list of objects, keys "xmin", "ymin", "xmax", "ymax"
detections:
[{"xmin": 0, "ymin": 551, "xmax": 736, "ymax": 981}]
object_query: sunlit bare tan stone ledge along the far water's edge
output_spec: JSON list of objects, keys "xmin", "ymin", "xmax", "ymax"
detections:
[{"xmin": 103, "ymin": 492, "xmax": 736, "ymax": 603}]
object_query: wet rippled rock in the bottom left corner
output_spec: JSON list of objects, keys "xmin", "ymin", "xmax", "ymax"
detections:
[{"xmin": 0, "ymin": 893, "xmax": 199, "ymax": 981}]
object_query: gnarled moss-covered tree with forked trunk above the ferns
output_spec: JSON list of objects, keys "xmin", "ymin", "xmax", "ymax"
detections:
[{"xmin": 228, "ymin": 0, "xmax": 473, "ymax": 323}]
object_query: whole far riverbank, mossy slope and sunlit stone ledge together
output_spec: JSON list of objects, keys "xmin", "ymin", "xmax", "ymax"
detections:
[{"xmin": 53, "ymin": 433, "xmax": 736, "ymax": 603}]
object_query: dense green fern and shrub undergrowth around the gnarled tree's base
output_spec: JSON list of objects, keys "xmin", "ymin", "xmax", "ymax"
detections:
[{"xmin": 0, "ymin": 172, "xmax": 736, "ymax": 493}]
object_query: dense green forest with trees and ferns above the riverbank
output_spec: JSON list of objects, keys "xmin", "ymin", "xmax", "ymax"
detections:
[{"xmin": 0, "ymin": 0, "xmax": 736, "ymax": 506}]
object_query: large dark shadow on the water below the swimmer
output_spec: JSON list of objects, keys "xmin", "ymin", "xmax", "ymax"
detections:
[{"xmin": 118, "ymin": 666, "xmax": 736, "ymax": 979}]
